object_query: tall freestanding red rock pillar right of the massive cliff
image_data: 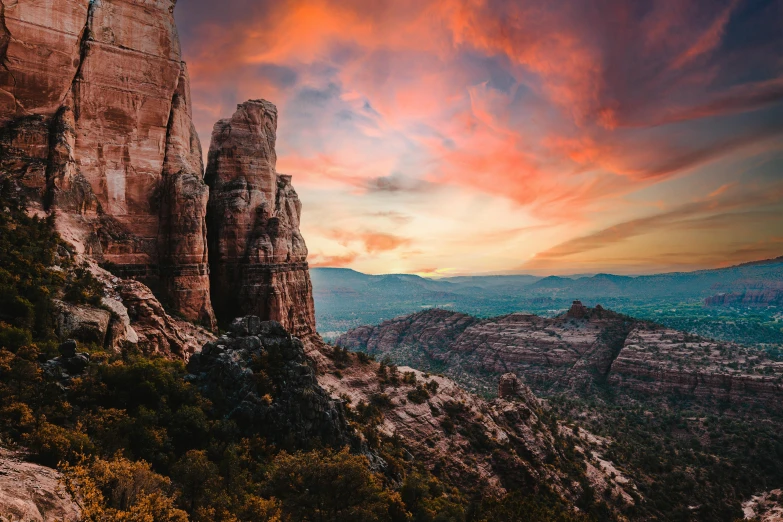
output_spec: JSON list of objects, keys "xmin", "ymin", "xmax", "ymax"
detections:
[{"xmin": 206, "ymin": 100, "xmax": 315, "ymax": 337}]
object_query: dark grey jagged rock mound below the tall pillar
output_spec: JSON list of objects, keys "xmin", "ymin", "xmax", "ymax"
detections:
[{"xmin": 188, "ymin": 316, "xmax": 356, "ymax": 449}]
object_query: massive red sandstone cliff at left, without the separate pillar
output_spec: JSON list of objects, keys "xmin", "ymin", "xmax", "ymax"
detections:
[{"xmin": 0, "ymin": 0, "xmax": 214, "ymax": 327}]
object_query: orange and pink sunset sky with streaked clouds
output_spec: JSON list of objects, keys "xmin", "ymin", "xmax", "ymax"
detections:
[{"xmin": 175, "ymin": 0, "xmax": 783, "ymax": 277}]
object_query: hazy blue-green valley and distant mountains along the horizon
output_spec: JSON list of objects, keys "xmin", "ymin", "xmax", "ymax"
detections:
[{"xmin": 311, "ymin": 257, "xmax": 783, "ymax": 344}]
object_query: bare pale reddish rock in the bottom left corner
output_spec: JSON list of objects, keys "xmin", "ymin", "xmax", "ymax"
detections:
[{"xmin": 0, "ymin": 448, "xmax": 81, "ymax": 522}]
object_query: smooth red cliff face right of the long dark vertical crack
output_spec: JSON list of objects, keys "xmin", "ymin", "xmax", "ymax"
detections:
[{"xmin": 72, "ymin": 0, "xmax": 181, "ymax": 266}]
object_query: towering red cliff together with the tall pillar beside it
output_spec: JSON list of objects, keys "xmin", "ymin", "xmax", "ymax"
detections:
[{"xmin": 0, "ymin": 0, "xmax": 315, "ymax": 335}]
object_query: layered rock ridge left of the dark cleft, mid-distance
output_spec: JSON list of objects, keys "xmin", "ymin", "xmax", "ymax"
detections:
[{"xmin": 336, "ymin": 304, "xmax": 627, "ymax": 394}]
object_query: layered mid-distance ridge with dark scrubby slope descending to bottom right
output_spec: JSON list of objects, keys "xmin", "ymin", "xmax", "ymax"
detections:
[{"xmin": 337, "ymin": 303, "xmax": 783, "ymax": 521}]
